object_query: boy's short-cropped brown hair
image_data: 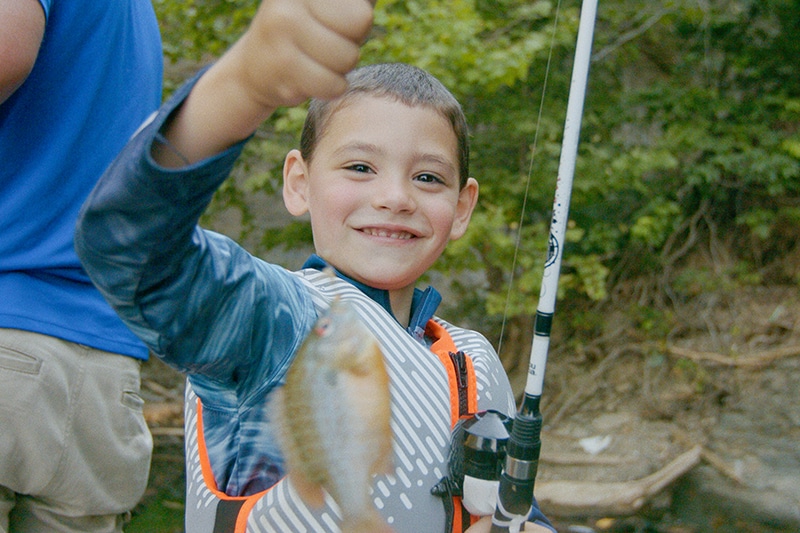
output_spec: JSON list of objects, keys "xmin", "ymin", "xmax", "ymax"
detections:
[{"xmin": 300, "ymin": 63, "xmax": 469, "ymax": 187}]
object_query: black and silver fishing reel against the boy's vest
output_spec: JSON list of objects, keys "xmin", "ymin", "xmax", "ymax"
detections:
[{"xmin": 431, "ymin": 409, "xmax": 514, "ymax": 532}]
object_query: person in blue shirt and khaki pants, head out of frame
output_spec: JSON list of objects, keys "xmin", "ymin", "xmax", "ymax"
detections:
[{"xmin": 0, "ymin": 0, "xmax": 162, "ymax": 532}]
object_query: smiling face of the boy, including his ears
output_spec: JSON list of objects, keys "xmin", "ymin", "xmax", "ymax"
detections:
[{"xmin": 284, "ymin": 96, "xmax": 478, "ymax": 290}]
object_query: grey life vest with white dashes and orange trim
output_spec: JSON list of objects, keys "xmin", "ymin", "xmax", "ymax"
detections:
[{"xmin": 184, "ymin": 270, "xmax": 515, "ymax": 533}]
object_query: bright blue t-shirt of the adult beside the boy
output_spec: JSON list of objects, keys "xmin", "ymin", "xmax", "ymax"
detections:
[{"xmin": 0, "ymin": 0, "xmax": 162, "ymax": 359}]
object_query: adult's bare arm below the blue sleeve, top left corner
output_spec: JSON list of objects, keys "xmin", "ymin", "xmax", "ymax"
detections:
[{"xmin": 0, "ymin": 0, "xmax": 45, "ymax": 104}]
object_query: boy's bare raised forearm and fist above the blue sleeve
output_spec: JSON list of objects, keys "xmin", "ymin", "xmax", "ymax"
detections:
[{"xmin": 153, "ymin": 0, "xmax": 374, "ymax": 167}]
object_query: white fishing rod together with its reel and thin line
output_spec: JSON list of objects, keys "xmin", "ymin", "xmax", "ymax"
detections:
[{"xmin": 444, "ymin": 0, "xmax": 597, "ymax": 533}]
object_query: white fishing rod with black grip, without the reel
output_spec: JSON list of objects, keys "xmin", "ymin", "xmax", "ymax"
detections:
[{"xmin": 491, "ymin": 0, "xmax": 597, "ymax": 533}]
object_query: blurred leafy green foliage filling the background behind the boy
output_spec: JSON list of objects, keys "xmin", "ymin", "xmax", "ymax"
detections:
[{"xmin": 155, "ymin": 0, "xmax": 800, "ymax": 342}]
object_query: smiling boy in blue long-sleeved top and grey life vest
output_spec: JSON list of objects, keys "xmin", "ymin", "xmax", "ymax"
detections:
[{"xmin": 76, "ymin": 0, "xmax": 546, "ymax": 532}]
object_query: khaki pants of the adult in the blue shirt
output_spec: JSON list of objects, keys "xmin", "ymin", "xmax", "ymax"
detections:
[{"xmin": 0, "ymin": 328, "xmax": 153, "ymax": 533}]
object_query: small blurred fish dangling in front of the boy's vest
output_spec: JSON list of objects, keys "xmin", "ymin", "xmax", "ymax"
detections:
[{"xmin": 277, "ymin": 300, "xmax": 392, "ymax": 533}]
